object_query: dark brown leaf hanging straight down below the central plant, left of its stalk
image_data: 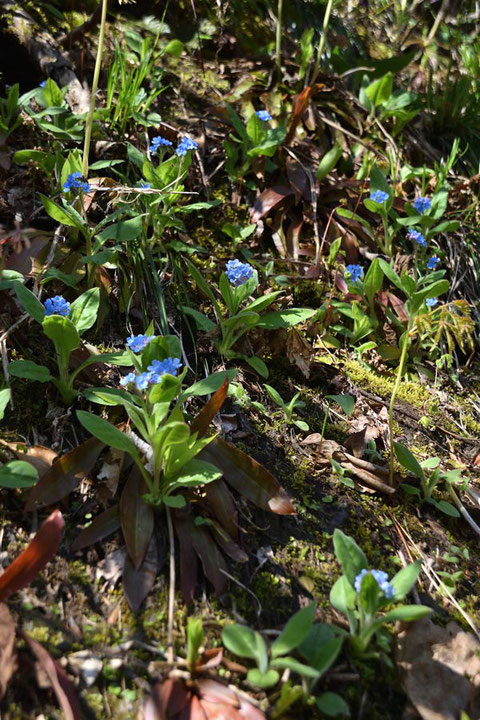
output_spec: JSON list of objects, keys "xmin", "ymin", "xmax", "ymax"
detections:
[{"xmin": 120, "ymin": 465, "xmax": 154, "ymax": 570}]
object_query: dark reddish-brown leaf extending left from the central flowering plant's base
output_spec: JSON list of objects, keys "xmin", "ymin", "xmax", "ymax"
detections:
[{"xmin": 26, "ymin": 437, "xmax": 105, "ymax": 510}]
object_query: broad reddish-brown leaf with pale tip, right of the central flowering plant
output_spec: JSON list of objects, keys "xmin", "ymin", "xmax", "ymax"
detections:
[{"xmin": 199, "ymin": 437, "xmax": 295, "ymax": 515}]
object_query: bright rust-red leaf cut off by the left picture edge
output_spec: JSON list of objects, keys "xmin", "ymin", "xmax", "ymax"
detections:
[{"xmin": 0, "ymin": 510, "xmax": 64, "ymax": 602}]
